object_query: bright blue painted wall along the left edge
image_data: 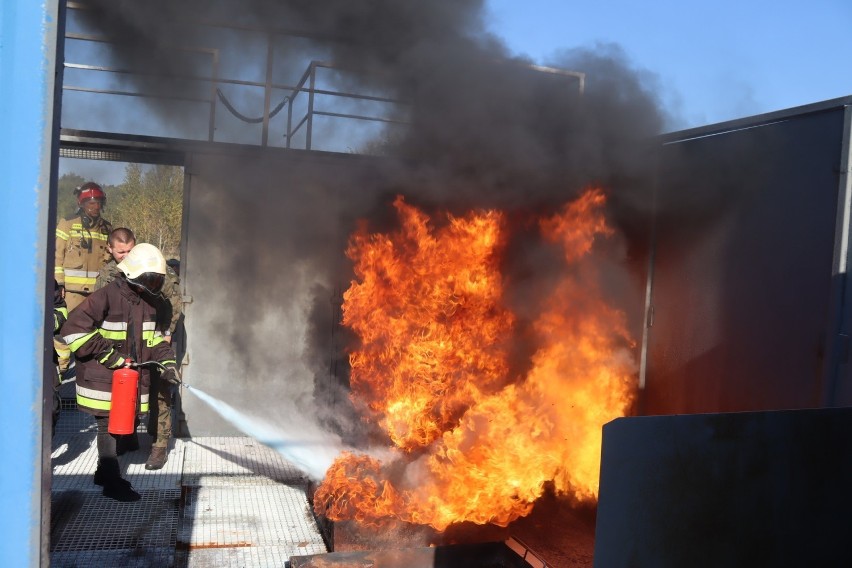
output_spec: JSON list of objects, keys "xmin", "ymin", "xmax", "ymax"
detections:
[{"xmin": 0, "ymin": 0, "xmax": 59, "ymax": 567}]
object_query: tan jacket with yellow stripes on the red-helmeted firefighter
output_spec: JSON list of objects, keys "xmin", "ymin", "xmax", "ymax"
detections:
[{"xmin": 54, "ymin": 215, "xmax": 112, "ymax": 294}]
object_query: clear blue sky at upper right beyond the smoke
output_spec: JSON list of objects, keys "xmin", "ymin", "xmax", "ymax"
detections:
[{"xmin": 487, "ymin": 0, "xmax": 852, "ymax": 128}]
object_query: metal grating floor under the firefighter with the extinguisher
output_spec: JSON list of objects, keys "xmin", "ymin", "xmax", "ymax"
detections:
[{"xmin": 50, "ymin": 400, "xmax": 327, "ymax": 568}]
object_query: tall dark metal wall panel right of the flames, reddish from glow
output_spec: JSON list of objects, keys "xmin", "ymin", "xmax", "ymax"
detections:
[{"xmin": 643, "ymin": 106, "xmax": 844, "ymax": 414}]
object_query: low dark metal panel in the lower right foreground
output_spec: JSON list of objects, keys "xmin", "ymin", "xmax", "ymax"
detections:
[{"xmin": 594, "ymin": 408, "xmax": 852, "ymax": 568}]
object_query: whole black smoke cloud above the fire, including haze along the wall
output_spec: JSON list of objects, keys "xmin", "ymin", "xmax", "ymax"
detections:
[{"xmin": 70, "ymin": 0, "xmax": 665, "ymax": 442}]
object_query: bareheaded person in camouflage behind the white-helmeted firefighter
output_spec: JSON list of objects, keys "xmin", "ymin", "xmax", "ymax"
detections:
[{"xmin": 95, "ymin": 227, "xmax": 183, "ymax": 470}]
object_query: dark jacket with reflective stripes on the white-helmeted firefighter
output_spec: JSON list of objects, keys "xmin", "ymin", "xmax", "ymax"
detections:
[{"xmin": 61, "ymin": 276, "xmax": 175, "ymax": 416}]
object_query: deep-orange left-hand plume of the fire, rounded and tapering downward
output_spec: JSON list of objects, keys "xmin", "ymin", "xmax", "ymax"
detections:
[{"xmin": 343, "ymin": 197, "xmax": 513, "ymax": 450}]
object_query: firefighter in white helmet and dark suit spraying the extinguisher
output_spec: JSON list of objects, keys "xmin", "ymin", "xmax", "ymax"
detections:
[{"xmin": 61, "ymin": 243, "xmax": 178, "ymax": 501}]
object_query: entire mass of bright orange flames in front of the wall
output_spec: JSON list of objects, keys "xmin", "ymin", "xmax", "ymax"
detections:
[{"xmin": 314, "ymin": 189, "xmax": 636, "ymax": 531}]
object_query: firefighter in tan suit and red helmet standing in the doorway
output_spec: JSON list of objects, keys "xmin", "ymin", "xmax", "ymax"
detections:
[{"xmin": 54, "ymin": 181, "xmax": 112, "ymax": 373}]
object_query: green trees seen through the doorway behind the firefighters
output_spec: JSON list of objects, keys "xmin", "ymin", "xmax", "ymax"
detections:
[{"xmin": 56, "ymin": 164, "xmax": 183, "ymax": 258}]
